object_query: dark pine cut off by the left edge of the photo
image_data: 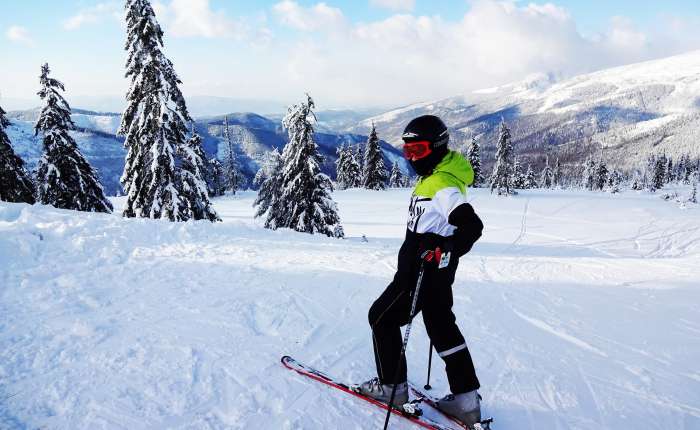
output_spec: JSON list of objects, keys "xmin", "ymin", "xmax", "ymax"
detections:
[{"xmin": 0, "ymin": 107, "xmax": 36, "ymax": 204}]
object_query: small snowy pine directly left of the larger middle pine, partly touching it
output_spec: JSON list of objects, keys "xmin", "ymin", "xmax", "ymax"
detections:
[{"xmin": 253, "ymin": 148, "xmax": 286, "ymax": 230}]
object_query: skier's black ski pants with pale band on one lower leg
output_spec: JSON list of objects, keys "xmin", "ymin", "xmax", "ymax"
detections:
[{"xmin": 369, "ymin": 255, "xmax": 480, "ymax": 394}]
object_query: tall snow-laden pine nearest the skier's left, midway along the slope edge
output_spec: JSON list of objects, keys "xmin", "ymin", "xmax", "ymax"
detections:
[{"xmin": 277, "ymin": 94, "xmax": 340, "ymax": 236}]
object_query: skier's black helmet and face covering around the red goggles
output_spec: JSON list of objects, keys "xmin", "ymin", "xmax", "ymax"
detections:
[{"xmin": 401, "ymin": 115, "xmax": 450, "ymax": 176}]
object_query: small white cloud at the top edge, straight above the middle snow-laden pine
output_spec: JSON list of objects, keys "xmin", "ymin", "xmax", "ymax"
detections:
[{"xmin": 273, "ymin": 0, "xmax": 347, "ymax": 31}]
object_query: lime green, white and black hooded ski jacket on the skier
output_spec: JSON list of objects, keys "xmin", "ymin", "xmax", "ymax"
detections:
[{"xmin": 398, "ymin": 151, "xmax": 484, "ymax": 286}]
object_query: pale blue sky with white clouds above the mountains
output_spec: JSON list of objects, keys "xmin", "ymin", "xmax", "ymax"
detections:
[{"xmin": 0, "ymin": 0, "xmax": 700, "ymax": 108}]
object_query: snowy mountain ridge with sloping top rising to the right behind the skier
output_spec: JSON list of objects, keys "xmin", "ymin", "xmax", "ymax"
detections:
[{"xmin": 356, "ymin": 51, "xmax": 700, "ymax": 169}]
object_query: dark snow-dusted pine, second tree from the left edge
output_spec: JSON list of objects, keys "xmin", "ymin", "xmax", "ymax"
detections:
[{"xmin": 34, "ymin": 64, "xmax": 113, "ymax": 213}]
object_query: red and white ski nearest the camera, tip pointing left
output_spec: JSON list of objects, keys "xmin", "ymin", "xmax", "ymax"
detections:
[{"xmin": 281, "ymin": 355, "xmax": 461, "ymax": 430}]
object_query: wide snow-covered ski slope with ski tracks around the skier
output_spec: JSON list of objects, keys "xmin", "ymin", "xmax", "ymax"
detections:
[{"xmin": 0, "ymin": 190, "xmax": 700, "ymax": 430}]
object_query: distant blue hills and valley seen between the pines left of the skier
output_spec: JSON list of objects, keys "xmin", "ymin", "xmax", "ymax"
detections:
[{"xmin": 7, "ymin": 108, "xmax": 409, "ymax": 195}]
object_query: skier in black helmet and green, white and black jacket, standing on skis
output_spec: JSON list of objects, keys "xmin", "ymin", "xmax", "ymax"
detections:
[{"xmin": 354, "ymin": 115, "xmax": 483, "ymax": 426}]
